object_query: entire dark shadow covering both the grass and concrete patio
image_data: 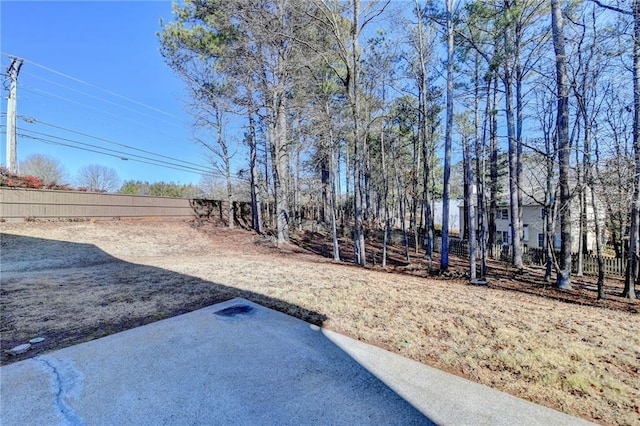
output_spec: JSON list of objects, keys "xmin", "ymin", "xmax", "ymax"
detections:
[{"xmin": 0, "ymin": 234, "xmax": 435, "ymax": 425}]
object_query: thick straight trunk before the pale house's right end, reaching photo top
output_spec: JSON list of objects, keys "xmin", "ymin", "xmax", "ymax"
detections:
[{"xmin": 551, "ymin": 0, "xmax": 571, "ymax": 289}]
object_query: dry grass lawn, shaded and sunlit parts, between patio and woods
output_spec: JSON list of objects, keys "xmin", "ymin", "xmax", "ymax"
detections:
[{"xmin": 0, "ymin": 220, "xmax": 640, "ymax": 425}]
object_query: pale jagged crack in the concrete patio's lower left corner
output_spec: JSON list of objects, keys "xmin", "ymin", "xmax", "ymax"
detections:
[{"xmin": 34, "ymin": 356, "xmax": 84, "ymax": 426}]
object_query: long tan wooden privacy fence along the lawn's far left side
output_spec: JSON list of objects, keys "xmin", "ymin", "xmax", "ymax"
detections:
[{"xmin": 0, "ymin": 187, "xmax": 251, "ymax": 226}]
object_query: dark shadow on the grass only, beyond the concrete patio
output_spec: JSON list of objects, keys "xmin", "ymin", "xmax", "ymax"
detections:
[{"xmin": 0, "ymin": 234, "xmax": 326, "ymax": 365}]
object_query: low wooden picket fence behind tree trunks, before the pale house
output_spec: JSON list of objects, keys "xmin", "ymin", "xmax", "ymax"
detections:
[{"xmin": 434, "ymin": 237, "xmax": 626, "ymax": 277}]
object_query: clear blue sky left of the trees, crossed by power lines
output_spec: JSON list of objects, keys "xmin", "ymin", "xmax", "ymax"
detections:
[{"xmin": 0, "ymin": 0, "xmax": 224, "ymax": 183}]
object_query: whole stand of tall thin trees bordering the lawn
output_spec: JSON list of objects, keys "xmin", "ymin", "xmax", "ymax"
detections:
[{"xmin": 158, "ymin": 0, "xmax": 640, "ymax": 295}]
